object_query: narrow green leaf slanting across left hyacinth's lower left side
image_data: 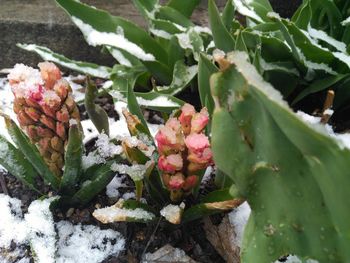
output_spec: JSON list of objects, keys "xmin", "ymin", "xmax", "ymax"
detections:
[{"xmin": 5, "ymin": 117, "xmax": 60, "ymax": 190}]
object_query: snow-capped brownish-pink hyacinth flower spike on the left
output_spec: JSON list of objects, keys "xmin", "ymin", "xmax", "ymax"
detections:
[{"xmin": 8, "ymin": 62, "xmax": 80, "ymax": 176}]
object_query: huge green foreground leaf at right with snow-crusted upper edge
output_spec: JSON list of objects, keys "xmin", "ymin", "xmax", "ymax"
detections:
[{"xmin": 211, "ymin": 52, "xmax": 350, "ymax": 263}]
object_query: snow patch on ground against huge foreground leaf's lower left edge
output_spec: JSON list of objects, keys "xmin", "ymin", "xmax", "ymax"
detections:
[{"xmin": 228, "ymin": 202, "xmax": 251, "ymax": 247}]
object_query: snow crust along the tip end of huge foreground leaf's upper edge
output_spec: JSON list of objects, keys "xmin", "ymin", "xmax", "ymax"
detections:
[{"xmin": 227, "ymin": 51, "xmax": 289, "ymax": 109}]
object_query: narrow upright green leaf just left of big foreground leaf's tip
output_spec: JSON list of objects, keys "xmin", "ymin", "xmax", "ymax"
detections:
[{"xmin": 198, "ymin": 54, "xmax": 219, "ymax": 116}]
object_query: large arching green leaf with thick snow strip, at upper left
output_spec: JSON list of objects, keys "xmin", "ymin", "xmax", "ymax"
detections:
[{"xmin": 56, "ymin": 0, "xmax": 171, "ymax": 83}]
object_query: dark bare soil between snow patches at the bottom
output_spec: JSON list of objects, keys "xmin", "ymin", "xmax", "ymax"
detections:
[{"xmin": 0, "ymin": 167, "xmax": 225, "ymax": 263}]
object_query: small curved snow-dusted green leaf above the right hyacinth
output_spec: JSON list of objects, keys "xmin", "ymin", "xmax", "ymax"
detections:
[{"xmin": 157, "ymin": 60, "xmax": 198, "ymax": 95}]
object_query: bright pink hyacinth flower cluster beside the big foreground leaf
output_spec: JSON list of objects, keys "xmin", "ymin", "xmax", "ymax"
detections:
[{"xmin": 156, "ymin": 104, "xmax": 213, "ymax": 201}]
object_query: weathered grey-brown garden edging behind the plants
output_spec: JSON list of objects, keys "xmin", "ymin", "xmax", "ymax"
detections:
[{"xmin": 0, "ymin": 0, "xmax": 301, "ymax": 69}]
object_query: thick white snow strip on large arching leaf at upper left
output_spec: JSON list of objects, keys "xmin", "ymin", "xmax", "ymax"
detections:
[{"xmin": 71, "ymin": 16, "xmax": 155, "ymax": 61}]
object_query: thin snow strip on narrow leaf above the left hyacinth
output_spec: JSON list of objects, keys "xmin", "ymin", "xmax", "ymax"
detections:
[{"xmin": 21, "ymin": 44, "xmax": 110, "ymax": 79}]
